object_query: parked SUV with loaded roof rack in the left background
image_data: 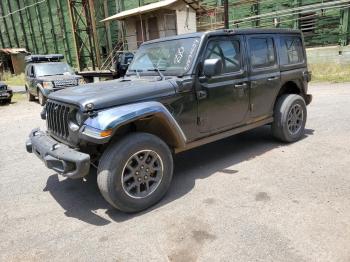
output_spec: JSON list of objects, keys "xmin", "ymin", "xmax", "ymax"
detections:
[{"xmin": 25, "ymin": 54, "xmax": 84, "ymax": 106}]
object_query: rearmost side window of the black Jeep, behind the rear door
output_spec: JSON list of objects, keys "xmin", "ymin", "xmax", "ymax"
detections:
[{"xmin": 280, "ymin": 36, "xmax": 304, "ymax": 65}]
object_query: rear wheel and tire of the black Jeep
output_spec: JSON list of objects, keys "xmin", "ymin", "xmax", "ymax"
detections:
[{"xmin": 271, "ymin": 94, "xmax": 307, "ymax": 143}]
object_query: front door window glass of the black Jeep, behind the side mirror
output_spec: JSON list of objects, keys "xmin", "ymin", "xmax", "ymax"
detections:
[{"xmin": 205, "ymin": 40, "xmax": 241, "ymax": 73}]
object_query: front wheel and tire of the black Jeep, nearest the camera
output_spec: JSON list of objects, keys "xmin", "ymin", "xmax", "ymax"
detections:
[{"xmin": 97, "ymin": 133, "xmax": 173, "ymax": 213}]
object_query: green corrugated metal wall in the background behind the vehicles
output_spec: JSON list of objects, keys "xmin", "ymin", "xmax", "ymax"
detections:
[{"xmin": 0, "ymin": 0, "xmax": 350, "ymax": 69}]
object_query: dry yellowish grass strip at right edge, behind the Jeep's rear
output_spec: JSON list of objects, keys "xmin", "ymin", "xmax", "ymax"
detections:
[{"xmin": 309, "ymin": 63, "xmax": 350, "ymax": 83}]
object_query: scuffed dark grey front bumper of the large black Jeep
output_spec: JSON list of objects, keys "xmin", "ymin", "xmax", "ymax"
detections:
[{"xmin": 26, "ymin": 129, "xmax": 90, "ymax": 178}]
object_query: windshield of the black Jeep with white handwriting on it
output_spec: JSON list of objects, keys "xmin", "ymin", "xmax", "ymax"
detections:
[{"xmin": 128, "ymin": 38, "xmax": 200, "ymax": 75}]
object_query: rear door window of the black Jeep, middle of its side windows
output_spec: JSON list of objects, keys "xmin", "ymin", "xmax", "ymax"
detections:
[{"xmin": 249, "ymin": 38, "xmax": 276, "ymax": 68}]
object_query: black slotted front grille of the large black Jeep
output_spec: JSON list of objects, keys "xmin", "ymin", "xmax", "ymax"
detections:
[{"xmin": 46, "ymin": 101, "xmax": 71, "ymax": 138}]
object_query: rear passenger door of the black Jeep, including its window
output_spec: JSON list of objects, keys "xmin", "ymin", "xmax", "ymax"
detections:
[{"xmin": 247, "ymin": 35, "xmax": 281, "ymax": 120}]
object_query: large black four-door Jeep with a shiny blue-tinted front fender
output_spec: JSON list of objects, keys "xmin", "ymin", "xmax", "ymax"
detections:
[{"xmin": 26, "ymin": 29, "xmax": 311, "ymax": 212}]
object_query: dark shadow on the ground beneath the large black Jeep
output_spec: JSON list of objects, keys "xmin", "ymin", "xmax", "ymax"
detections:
[{"xmin": 44, "ymin": 126, "xmax": 314, "ymax": 226}]
